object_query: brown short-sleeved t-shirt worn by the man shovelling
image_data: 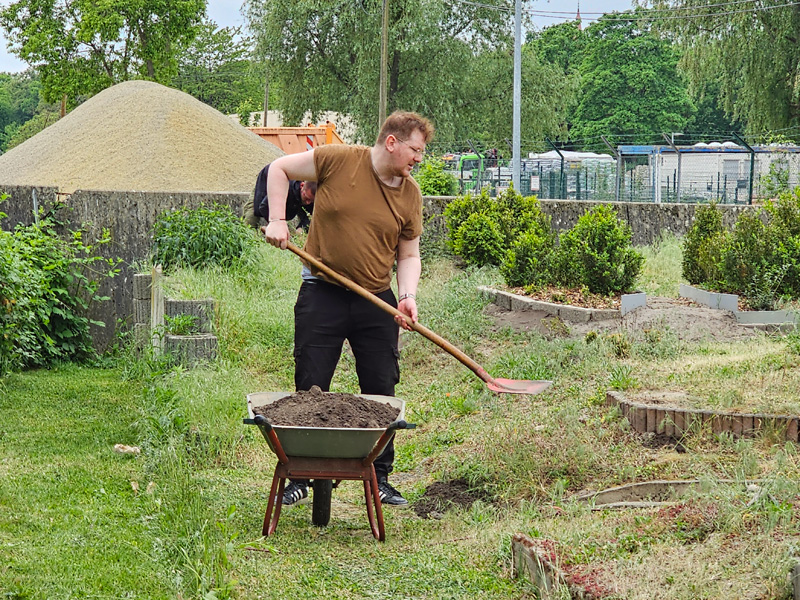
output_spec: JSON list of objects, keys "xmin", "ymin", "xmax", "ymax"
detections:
[{"xmin": 305, "ymin": 145, "xmax": 422, "ymax": 293}]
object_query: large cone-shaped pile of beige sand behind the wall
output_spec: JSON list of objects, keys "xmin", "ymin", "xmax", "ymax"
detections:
[{"xmin": 0, "ymin": 81, "xmax": 283, "ymax": 193}]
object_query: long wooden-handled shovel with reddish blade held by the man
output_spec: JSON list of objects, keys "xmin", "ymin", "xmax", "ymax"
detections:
[{"xmin": 287, "ymin": 243, "xmax": 553, "ymax": 394}]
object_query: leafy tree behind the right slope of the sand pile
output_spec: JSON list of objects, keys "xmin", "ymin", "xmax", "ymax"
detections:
[{"xmin": 173, "ymin": 20, "xmax": 264, "ymax": 114}]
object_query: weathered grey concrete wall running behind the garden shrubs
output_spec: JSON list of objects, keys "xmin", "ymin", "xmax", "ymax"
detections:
[{"xmin": 0, "ymin": 187, "xmax": 748, "ymax": 348}]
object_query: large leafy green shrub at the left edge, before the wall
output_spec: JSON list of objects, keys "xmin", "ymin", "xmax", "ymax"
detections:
[{"xmin": 0, "ymin": 206, "xmax": 118, "ymax": 374}]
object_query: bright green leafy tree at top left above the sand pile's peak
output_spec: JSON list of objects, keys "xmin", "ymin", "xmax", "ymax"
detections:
[{"xmin": 0, "ymin": 0, "xmax": 206, "ymax": 102}]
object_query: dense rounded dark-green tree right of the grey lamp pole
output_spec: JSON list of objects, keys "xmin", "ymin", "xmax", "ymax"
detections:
[{"xmin": 571, "ymin": 12, "xmax": 694, "ymax": 145}]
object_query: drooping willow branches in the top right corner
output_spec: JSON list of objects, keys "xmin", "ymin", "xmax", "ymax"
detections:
[{"xmin": 640, "ymin": 0, "xmax": 800, "ymax": 133}]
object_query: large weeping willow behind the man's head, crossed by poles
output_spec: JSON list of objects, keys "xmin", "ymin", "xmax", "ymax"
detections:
[{"xmin": 245, "ymin": 0, "xmax": 570, "ymax": 142}]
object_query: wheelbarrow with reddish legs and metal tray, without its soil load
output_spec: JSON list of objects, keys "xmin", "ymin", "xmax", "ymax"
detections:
[{"xmin": 244, "ymin": 392, "xmax": 416, "ymax": 541}]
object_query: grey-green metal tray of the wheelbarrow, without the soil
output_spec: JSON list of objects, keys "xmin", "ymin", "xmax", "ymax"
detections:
[{"xmin": 247, "ymin": 392, "xmax": 406, "ymax": 458}]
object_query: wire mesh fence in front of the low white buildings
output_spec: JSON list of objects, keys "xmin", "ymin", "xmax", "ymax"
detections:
[{"xmin": 434, "ymin": 141, "xmax": 800, "ymax": 204}]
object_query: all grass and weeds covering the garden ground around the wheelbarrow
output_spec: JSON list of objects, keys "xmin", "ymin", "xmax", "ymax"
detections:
[{"xmin": 0, "ymin": 237, "xmax": 800, "ymax": 600}]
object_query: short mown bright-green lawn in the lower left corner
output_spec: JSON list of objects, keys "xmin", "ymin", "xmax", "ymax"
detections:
[{"xmin": 0, "ymin": 366, "xmax": 171, "ymax": 598}]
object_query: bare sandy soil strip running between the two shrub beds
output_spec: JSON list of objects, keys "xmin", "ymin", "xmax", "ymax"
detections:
[{"xmin": 486, "ymin": 297, "xmax": 761, "ymax": 342}]
